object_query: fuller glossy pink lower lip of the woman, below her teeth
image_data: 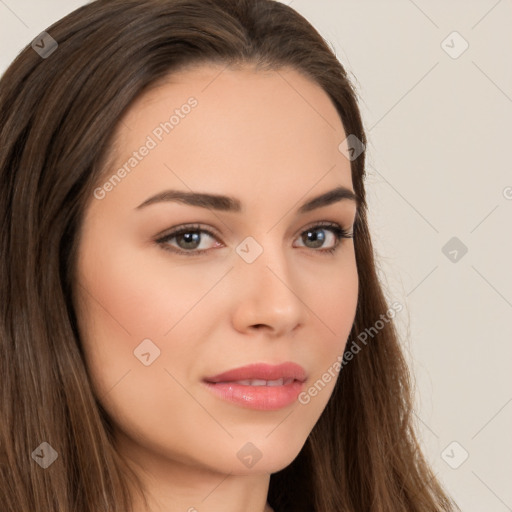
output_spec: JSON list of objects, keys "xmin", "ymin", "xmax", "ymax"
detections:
[{"xmin": 205, "ymin": 380, "xmax": 304, "ymax": 411}]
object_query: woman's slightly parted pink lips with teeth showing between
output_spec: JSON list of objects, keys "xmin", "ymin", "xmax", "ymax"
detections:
[{"xmin": 203, "ymin": 363, "xmax": 306, "ymax": 411}]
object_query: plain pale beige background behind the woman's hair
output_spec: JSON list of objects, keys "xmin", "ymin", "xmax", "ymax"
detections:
[{"xmin": 0, "ymin": 0, "xmax": 512, "ymax": 512}]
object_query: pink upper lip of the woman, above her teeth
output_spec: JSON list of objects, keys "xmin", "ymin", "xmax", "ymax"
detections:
[{"xmin": 204, "ymin": 362, "xmax": 306, "ymax": 383}]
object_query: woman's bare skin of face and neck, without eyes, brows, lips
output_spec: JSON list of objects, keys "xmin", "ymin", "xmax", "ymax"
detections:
[{"xmin": 75, "ymin": 65, "xmax": 358, "ymax": 512}]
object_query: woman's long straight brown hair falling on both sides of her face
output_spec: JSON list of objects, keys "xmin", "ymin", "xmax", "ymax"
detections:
[{"xmin": 0, "ymin": 0, "xmax": 455, "ymax": 512}]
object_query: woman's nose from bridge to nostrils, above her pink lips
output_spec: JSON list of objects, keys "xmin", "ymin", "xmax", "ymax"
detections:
[{"xmin": 233, "ymin": 240, "xmax": 307, "ymax": 337}]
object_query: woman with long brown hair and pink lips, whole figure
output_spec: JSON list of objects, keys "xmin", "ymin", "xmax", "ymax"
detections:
[{"xmin": 0, "ymin": 0, "xmax": 455, "ymax": 512}]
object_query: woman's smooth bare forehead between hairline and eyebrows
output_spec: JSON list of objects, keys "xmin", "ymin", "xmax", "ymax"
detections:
[{"xmin": 98, "ymin": 65, "xmax": 352, "ymax": 212}]
